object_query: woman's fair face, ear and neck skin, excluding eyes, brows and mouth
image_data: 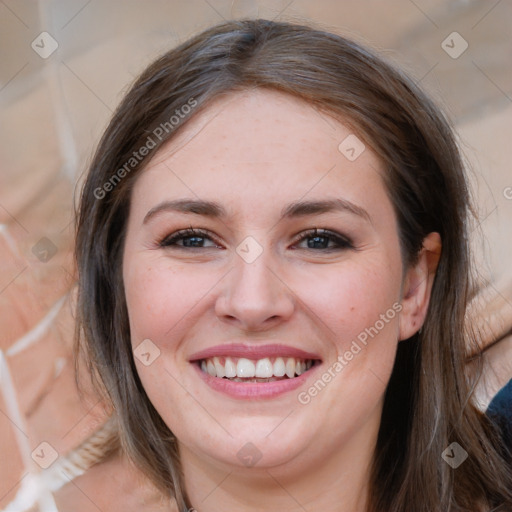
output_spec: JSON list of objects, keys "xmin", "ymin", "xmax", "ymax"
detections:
[{"xmin": 123, "ymin": 90, "xmax": 440, "ymax": 512}]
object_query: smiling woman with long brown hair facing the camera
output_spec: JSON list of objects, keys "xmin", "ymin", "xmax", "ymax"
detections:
[{"xmin": 72, "ymin": 20, "xmax": 512, "ymax": 512}]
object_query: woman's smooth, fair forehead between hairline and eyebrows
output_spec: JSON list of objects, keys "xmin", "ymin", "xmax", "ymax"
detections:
[{"xmin": 130, "ymin": 89, "xmax": 385, "ymax": 222}]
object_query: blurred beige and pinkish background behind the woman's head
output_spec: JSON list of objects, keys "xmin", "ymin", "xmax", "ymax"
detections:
[{"xmin": 0, "ymin": 0, "xmax": 512, "ymax": 510}]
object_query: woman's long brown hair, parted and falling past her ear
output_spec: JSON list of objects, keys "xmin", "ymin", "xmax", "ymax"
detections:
[{"xmin": 76, "ymin": 20, "xmax": 512, "ymax": 512}]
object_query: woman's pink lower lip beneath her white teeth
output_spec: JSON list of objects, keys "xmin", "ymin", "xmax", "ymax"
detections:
[{"xmin": 193, "ymin": 364, "xmax": 319, "ymax": 399}]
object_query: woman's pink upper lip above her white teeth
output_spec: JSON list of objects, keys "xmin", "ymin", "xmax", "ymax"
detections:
[{"xmin": 189, "ymin": 343, "xmax": 320, "ymax": 362}]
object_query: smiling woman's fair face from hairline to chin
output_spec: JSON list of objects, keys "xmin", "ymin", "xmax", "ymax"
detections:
[{"xmin": 123, "ymin": 90, "xmax": 412, "ymax": 480}]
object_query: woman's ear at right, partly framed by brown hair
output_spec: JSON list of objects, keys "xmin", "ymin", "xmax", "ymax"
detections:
[{"xmin": 399, "ymin": 233, "xmax": 442, "ymax": 341}]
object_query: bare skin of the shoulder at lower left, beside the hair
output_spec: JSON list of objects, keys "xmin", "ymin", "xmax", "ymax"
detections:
[{"xmin": 55, "ymin": 454, "xmax": 178, "ymax": 512}]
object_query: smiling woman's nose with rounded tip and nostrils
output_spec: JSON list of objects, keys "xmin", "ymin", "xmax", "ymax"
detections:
[{"xmin": 215, "ymin": 251, "xmax": 295, "ymax": 331}]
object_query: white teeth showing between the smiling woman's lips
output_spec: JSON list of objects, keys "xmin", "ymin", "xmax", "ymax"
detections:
[{"xmin": 198, "ymin": 357, "xmax": 320, "ymax": 383}]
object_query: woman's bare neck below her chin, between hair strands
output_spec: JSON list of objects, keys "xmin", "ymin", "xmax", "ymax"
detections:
[{"xmin": 180, "ymin": 411, "xmax": 380, "ymax": 512}]
